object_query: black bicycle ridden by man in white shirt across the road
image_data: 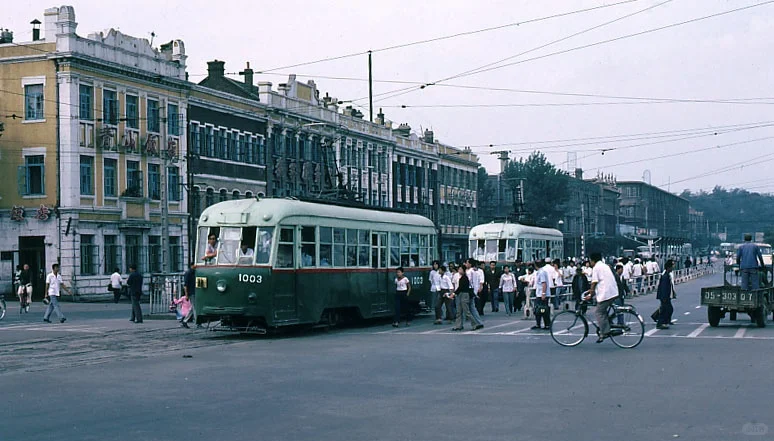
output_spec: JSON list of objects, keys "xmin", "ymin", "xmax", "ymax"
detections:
[{"xmin": 551, "ymin": 300, "xmax": 645, "ymax": 349}]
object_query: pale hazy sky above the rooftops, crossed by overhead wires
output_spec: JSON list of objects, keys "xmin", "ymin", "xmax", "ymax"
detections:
[{"xmin": 6, "ymin": 0, "xmax": 774, "ymax": 193}]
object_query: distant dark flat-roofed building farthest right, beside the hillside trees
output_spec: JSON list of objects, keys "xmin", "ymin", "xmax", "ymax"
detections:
[{"xmin": 617, "ymin": 181, "xmax": 690, "ymax": 256}]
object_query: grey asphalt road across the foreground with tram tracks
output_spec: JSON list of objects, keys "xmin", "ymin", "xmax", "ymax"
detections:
[{"xmin": 0, "ymin": 270, "xmax": 774, "ymax": 441}]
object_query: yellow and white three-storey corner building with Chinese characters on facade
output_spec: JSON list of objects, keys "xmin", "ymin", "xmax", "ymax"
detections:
[{"xmin": 0, "ymin": 6, "xmax": 190, "ymax": 294}]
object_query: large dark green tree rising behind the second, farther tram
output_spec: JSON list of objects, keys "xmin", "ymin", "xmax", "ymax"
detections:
[{"xmin": 505, "ymin": 152, "xmax": 570, "ymax": 227}]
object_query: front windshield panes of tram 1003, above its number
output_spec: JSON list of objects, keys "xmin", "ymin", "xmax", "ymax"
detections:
[{"xmin": 196, "ymin": 227, "xmax": 274, "ymax": 265}]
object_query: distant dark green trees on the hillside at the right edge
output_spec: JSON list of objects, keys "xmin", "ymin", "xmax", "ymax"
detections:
[{"xmin": 680, "ymin": 187, "xmax": 774, "ymax": 242}]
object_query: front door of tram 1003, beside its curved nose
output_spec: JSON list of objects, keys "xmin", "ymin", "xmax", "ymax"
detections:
[{"xmin": 272, "ymin": 226, "xmax": 299, "ymax": 322}]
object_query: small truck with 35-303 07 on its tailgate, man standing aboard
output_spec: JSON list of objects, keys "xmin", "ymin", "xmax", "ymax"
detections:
[{"xmin": 701, "ymin": 264, "xmax": 774, "ymax": 328}]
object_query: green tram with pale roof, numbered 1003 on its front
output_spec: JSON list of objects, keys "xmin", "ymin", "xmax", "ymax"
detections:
[{"xmin": 195, "ymin": 199, "xmax": 437, "ymax": 332}]
